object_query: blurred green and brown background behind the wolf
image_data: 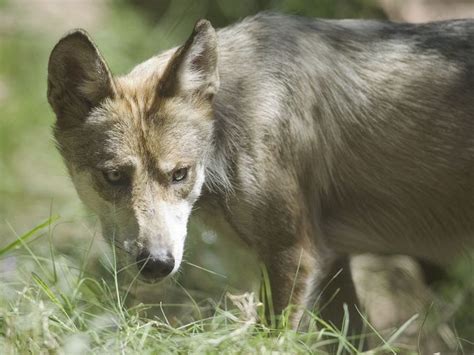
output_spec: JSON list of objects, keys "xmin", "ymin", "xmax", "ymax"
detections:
[{"xmin": 0, "ymin": 0, "xmax": 474, "ymax": 344}]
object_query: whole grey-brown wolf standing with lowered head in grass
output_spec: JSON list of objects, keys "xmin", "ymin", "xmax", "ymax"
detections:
[{"xmin": 47, "ymin": 13, "xmax": 474, "ymax": 336}]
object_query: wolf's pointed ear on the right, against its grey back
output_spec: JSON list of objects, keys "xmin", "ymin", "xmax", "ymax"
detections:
[{"xmin": 158, "ymin": 20, "xmax": 219, "ymax": 99}]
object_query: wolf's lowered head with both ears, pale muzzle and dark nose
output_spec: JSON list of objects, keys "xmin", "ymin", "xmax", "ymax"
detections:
[{"xmin": 48, "ymin": 20, "xmax": 219, "ymax": 282}]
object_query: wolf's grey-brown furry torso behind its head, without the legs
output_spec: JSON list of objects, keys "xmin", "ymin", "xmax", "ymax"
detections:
[{"xmin": 206, "ymin": 15, "xmax": 474, "ymax": 262}]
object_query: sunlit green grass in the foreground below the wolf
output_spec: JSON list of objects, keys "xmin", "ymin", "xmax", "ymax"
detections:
[{"xmin": 0, "ymin": 217, "xmax": 422, "ymax": 354}]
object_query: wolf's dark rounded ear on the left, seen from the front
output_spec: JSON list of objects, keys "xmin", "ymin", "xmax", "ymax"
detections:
[{"xmin": 48, "ymin": 30, "xmax": 114, "ymax": 127}]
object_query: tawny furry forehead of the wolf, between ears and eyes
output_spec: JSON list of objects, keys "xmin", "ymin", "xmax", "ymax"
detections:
[{"xmin": 90, "ymin": 97, "xmax": 212, "ymax": 165}]
